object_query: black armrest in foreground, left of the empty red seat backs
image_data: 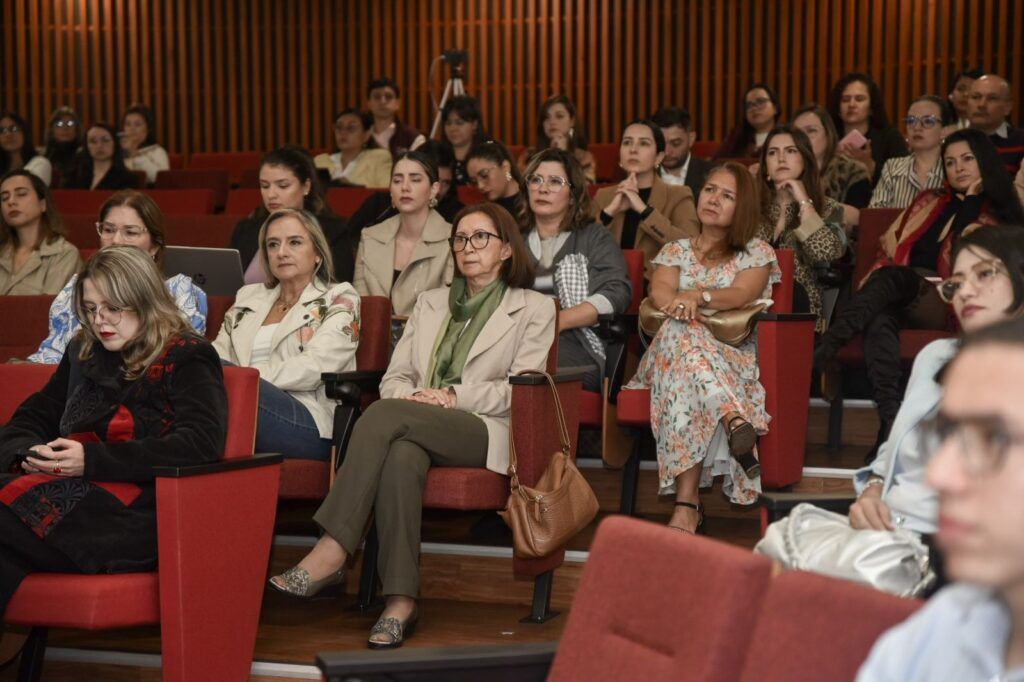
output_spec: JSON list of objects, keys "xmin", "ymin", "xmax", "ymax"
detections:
[{"xmin": 316, "ymin": 642, "xmax": 558, "ymax": 681}]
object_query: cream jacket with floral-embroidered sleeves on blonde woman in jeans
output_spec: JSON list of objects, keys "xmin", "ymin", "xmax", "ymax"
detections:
[{"xmin": 213, "ymin": 282, "xmax": 359, "ymax": 438}]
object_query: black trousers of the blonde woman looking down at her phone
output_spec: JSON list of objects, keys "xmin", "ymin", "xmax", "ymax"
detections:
[{"xmin": 0, "ymin": 504, "xmax": 81, "ymax": 615}]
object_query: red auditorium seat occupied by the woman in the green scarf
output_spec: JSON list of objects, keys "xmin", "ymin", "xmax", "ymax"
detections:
[{"xmin": 346, "ymin": 309, "xmax": 582, "ymax": 623}]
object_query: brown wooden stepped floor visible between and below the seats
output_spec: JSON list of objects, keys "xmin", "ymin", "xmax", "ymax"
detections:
[{"xmin": 0, "ymin": 399, "xmax": 877, "ymax": 682}]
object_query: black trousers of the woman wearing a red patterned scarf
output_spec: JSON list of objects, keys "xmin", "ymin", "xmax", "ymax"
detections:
[{"xmin": 814, "ymin": 265, "xmax": 948, "ymax": 435}]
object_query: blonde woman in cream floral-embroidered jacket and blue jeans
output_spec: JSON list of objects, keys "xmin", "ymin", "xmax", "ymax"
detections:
[{"xmin": 213, "ymin": 209, "xmax": 359, "ymax": 460}]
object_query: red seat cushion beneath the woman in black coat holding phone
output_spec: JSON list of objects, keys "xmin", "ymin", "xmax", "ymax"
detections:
[{"xmin": 4, "ymin": 571, "xmax": 160, "ymax": 630}]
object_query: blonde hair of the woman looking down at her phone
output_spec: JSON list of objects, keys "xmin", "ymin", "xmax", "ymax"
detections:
[{"xmin": 73, "ymin": 246, "xmax": 197, "ymax": 380}]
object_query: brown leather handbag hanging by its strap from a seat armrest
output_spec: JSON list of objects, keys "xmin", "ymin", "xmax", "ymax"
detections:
[{"xmin": 498, "ymin": 370, "xmax": 598, "ymax": 559}]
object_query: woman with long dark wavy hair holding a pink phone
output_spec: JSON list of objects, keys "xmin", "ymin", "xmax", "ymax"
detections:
[{"xmin": 828, "ymin": 74, "xmax": 906, "ymax": 184}]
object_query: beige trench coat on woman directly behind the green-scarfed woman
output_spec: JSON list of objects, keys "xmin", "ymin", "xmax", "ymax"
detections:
[{"xmin": 352, "ymin": 210, "xmax": 455, "ymax": 315}]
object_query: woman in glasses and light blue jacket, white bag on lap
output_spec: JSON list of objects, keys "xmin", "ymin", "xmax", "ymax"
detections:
[{"xmin": 759, "ymin": 225, "xmax": 1024, "ymax": 593}]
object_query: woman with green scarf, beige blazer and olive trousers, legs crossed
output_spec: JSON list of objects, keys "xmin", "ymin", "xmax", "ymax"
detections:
[{"xmin": 270, "ymin": 203, "xmax": 555, "ymax": 648}]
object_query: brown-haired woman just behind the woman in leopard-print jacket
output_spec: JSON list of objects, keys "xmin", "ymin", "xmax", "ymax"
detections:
[{"xmin": 790, "ymin": 104, "xmax": 871, "ymax": 227}]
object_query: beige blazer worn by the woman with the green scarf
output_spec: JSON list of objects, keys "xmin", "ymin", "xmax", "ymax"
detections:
[{"xmin": 381, "ymin": 288, "xmax": 555, "ymax": 474}]
